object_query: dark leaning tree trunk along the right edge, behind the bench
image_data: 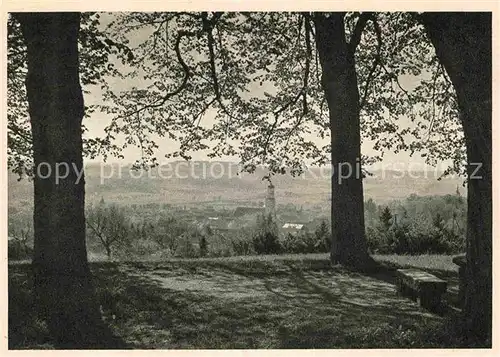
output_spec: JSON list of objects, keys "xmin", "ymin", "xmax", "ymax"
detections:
[{"xmin": 422, "ymin": 13, "xmax": 492, "ymax": 344}]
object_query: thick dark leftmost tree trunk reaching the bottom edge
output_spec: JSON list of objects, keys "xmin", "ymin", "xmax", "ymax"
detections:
[{"xmin": 15, "ymin": 13, "xmax": 100, "ymax": 348}]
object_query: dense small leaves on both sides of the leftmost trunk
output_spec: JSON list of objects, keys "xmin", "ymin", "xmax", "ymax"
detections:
[{"xmin": 7, "ymin": 12, "xmax": 131, "ymax": 178}]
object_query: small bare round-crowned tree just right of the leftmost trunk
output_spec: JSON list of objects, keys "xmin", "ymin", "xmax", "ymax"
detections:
[{"xmin": 86, "ymin": 203, "xmax": 132, "ymax": 259}]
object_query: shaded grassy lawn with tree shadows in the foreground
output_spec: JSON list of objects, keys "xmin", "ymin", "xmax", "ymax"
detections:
[{"xmin": 9, "ymin": 254, "xmax": 463, "ymax": 349}]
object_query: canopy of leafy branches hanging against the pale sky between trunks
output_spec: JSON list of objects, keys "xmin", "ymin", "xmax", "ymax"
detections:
[{"xmin": 8, "ymin": 12, "xmax": 465, "ymax": 178}]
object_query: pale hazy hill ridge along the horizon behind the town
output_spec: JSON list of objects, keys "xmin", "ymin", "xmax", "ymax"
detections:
[{"xmin": 8, "ymin": 162, "xmax": 466, "ymax": 206}]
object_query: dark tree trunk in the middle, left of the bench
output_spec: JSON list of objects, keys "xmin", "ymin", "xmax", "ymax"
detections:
[{"xmin": 314, "ymin": 13, "xmax": 369, "ymax": 268}]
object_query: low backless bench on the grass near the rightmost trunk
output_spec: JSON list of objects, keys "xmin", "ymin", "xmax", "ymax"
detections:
[{"xmin": 396, "ymin": 269, "xmax": 447, "ymax": 311}]
